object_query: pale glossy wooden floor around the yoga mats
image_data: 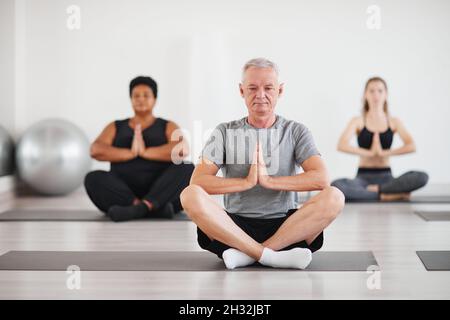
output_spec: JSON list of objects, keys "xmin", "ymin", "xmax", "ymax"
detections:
[{"xmin": 0, "ymin": 192, "xmax": 450, "ymax": 299}]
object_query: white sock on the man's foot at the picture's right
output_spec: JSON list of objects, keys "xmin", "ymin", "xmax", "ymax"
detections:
[{"xmin": 259, "ymin": 248, "xmax": 312, "ymax": 269}]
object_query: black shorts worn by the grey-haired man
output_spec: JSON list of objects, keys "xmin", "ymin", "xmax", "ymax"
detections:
[{"xmin": 197, "ymin": 209, "xmax": 323, "ymax": 258}]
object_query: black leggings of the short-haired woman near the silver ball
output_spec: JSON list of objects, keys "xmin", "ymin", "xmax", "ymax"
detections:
[{"xmin": 84, "ymin": 163, "xmax": 194, "ymax": 213}]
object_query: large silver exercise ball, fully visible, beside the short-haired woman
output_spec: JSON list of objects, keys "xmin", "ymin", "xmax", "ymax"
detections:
[{"xmin": 16, "ymin": 119, "xmax": 91, "ymax": 195}]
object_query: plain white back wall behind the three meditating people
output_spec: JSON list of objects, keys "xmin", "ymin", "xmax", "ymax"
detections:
[{"xmin": 8, "ymin": 0, "xmax": 450, "ymax": 183}]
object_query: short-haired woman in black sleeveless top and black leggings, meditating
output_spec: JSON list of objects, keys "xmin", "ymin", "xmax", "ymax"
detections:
[{"xmin": 84, "ymin": 77, "xmax": 194, "ymax": 221}]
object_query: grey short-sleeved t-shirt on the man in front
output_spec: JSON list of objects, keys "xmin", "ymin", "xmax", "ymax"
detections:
[{"xmin": 201, "ymin": 115, "xmax": 320, "ymax": 219}]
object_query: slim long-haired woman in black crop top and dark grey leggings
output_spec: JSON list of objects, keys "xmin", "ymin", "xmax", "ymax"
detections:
[{"xmin": 332, "ymin": 77, "xmax": 428, "ymax": 201}]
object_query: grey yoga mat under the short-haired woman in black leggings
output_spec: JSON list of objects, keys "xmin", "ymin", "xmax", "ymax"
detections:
[{"xmin": 0, "ymin": 209, "xmax": 190, "ymax": 221}]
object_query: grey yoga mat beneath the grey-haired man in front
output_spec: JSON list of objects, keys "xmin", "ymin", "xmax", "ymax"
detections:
[{"xmin": 0, "ymin": 251, "xmax": 377, "ymax": 271}]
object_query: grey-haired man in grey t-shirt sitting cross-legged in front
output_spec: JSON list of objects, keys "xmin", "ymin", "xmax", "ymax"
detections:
[{"xmin": 180, "ymin": 58, "xmax": 344, "ymax": 269}]
